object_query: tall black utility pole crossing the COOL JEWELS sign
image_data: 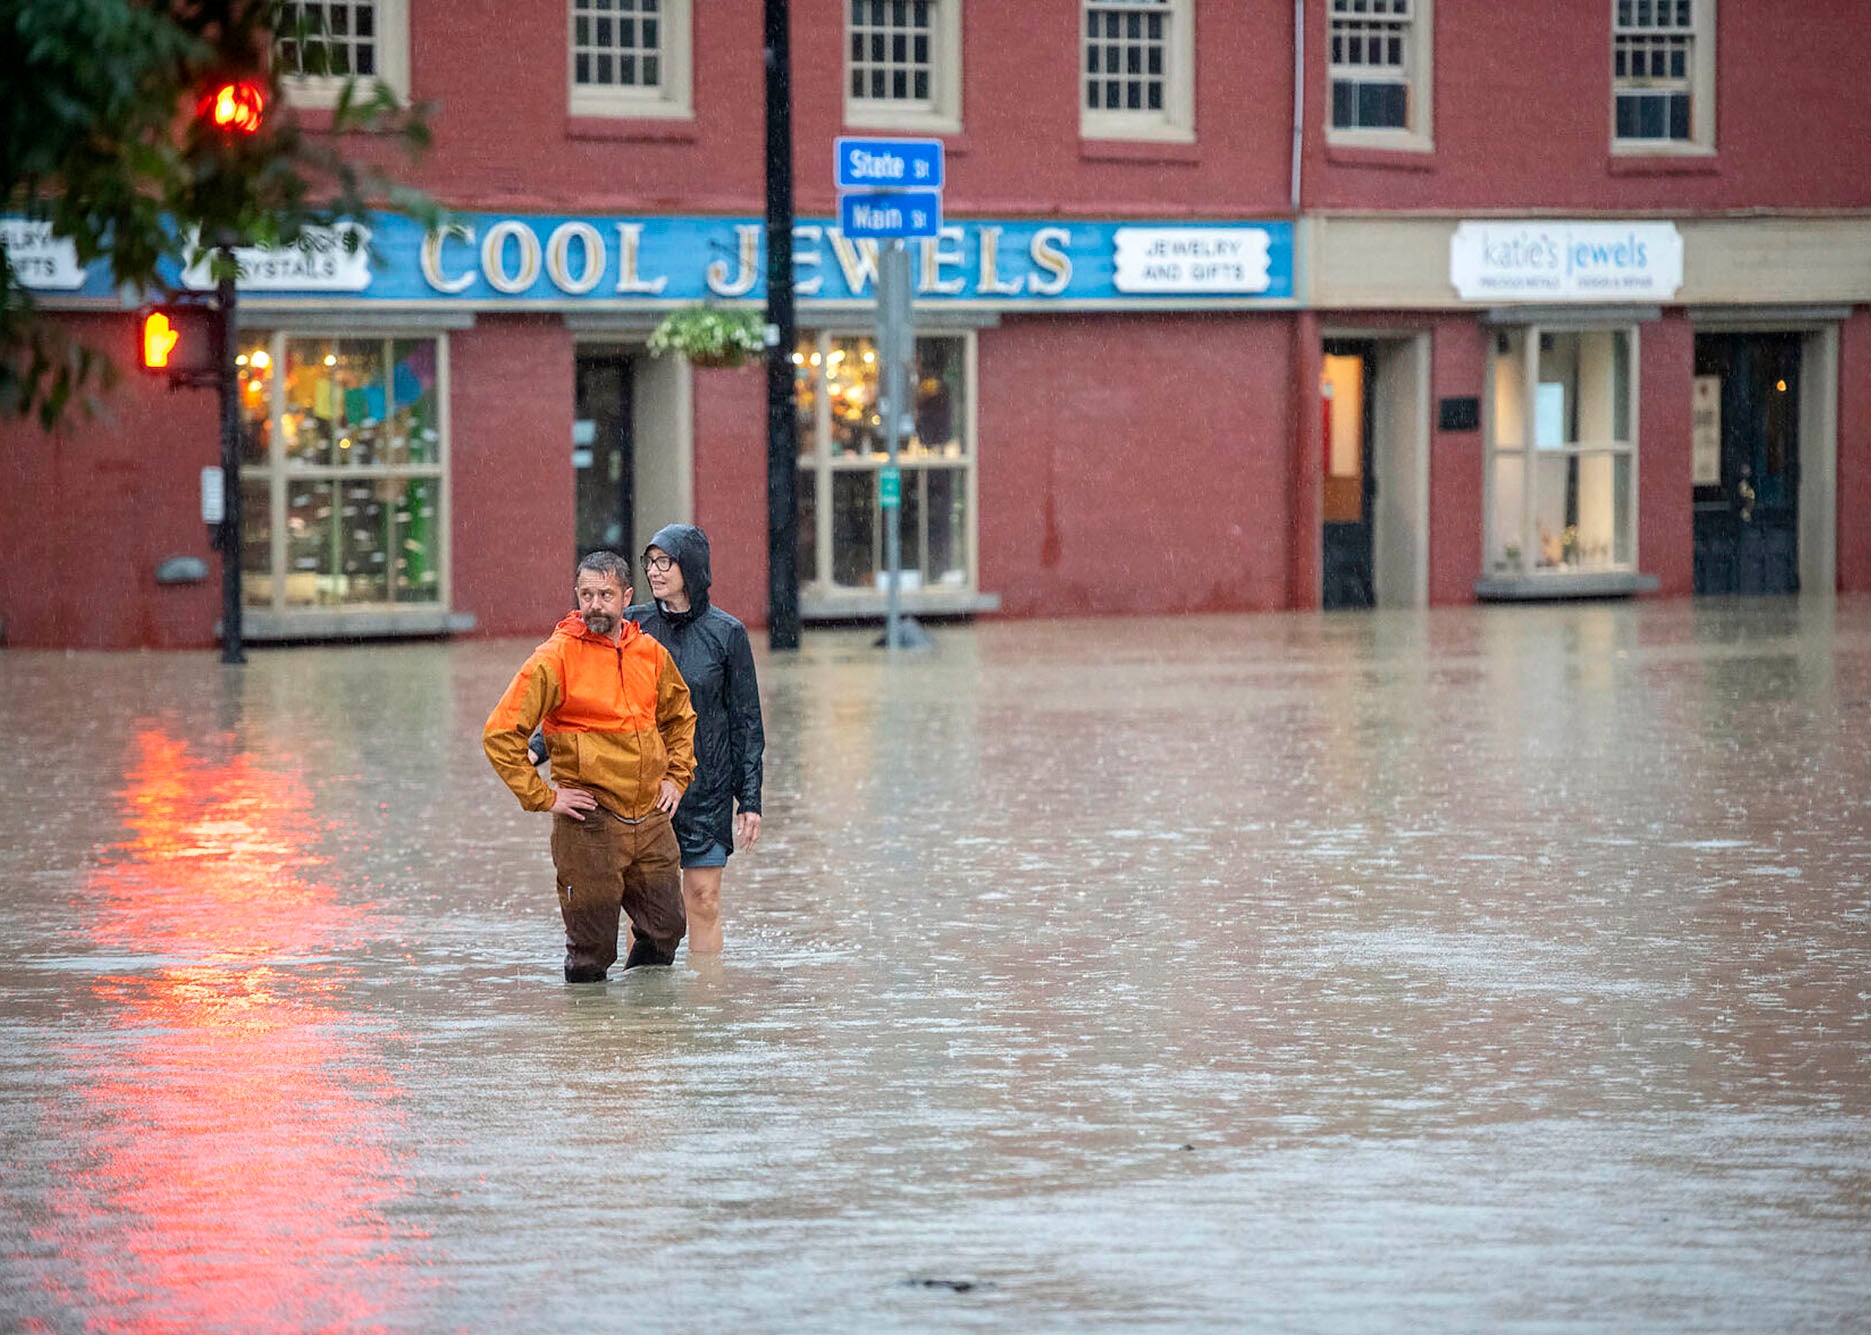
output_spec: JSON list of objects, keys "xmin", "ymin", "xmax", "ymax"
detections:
[{"xmin": 765, "ymin": 0, "xmax": 799, "ymax": 649}]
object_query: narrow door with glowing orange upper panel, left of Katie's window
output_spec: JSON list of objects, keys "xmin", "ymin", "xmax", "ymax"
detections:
[{"xmin": 1321, "ymin": 338, "xmax": 1377, "ymax": 608}]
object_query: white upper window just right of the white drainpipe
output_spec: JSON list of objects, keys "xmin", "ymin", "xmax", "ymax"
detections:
[{"xmin": 1327, "ymin": 0, "xmax": 1433, "ymax": 148}]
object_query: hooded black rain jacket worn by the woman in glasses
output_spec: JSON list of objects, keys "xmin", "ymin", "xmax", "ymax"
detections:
[{"xmin": 623, "ymin": 524, "xmax": 767, "ymax": 854}]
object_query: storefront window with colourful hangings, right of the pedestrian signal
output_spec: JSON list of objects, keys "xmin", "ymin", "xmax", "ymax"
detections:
[{"xmin": 238, "ymin": 333, "xmax": 445, "ymax": 611}]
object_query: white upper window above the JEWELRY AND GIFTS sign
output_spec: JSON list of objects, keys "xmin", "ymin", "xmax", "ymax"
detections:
[{"xmin": 1080, "ymin": 0, "xmax": 1196, "ymax": 140}]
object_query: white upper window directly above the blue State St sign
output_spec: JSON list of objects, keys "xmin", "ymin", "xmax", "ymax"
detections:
[{"xmin": 844, "ymin": 0, "xmax": 962, "ymax": 133}]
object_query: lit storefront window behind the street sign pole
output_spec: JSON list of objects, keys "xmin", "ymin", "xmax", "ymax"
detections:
[{"xmin": 793, "ymin": 333, "xmax": 975, "ymax": 595}]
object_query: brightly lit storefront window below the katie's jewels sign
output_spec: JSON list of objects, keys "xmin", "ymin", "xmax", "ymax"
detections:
[{"xmin": 1487, "ymin": 327, "xmax": 1637, "ymax": 576}]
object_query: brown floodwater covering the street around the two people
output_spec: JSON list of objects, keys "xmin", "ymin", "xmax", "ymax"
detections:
[{"xmin": 0, "ymin": 600, "xmax": 1871, "ymax": 1333}]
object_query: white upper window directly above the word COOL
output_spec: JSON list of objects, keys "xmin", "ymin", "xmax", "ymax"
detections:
[{"xmin": 571, "ymin": 0, "xmax": 694, "ymax": 116}]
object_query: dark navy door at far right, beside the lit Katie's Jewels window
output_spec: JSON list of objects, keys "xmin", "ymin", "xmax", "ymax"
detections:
[{"xmin": 1695, "ymin": 335, "xmax": 1800, "ymax": 595}]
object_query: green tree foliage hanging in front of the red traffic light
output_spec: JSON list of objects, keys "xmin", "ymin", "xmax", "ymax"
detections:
[{"xmin": 0, "ymin": 0, "xmax": 436, "ymax": 426}]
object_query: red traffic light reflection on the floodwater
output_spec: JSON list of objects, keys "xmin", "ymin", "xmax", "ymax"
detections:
[{"xmin": 41, "ymin": 727, "xmax": 424, "ymax": 1329}]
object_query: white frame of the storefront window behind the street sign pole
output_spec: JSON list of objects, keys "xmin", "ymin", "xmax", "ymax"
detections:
[{"xmin": 795, "ymin": 322, "xmax": 980, "ymax": 610}]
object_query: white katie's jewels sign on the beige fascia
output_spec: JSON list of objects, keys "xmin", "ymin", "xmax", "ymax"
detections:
[{"xmin": 1448, "ymin": 223, "xmax": 1682, "ymax": 301}]
